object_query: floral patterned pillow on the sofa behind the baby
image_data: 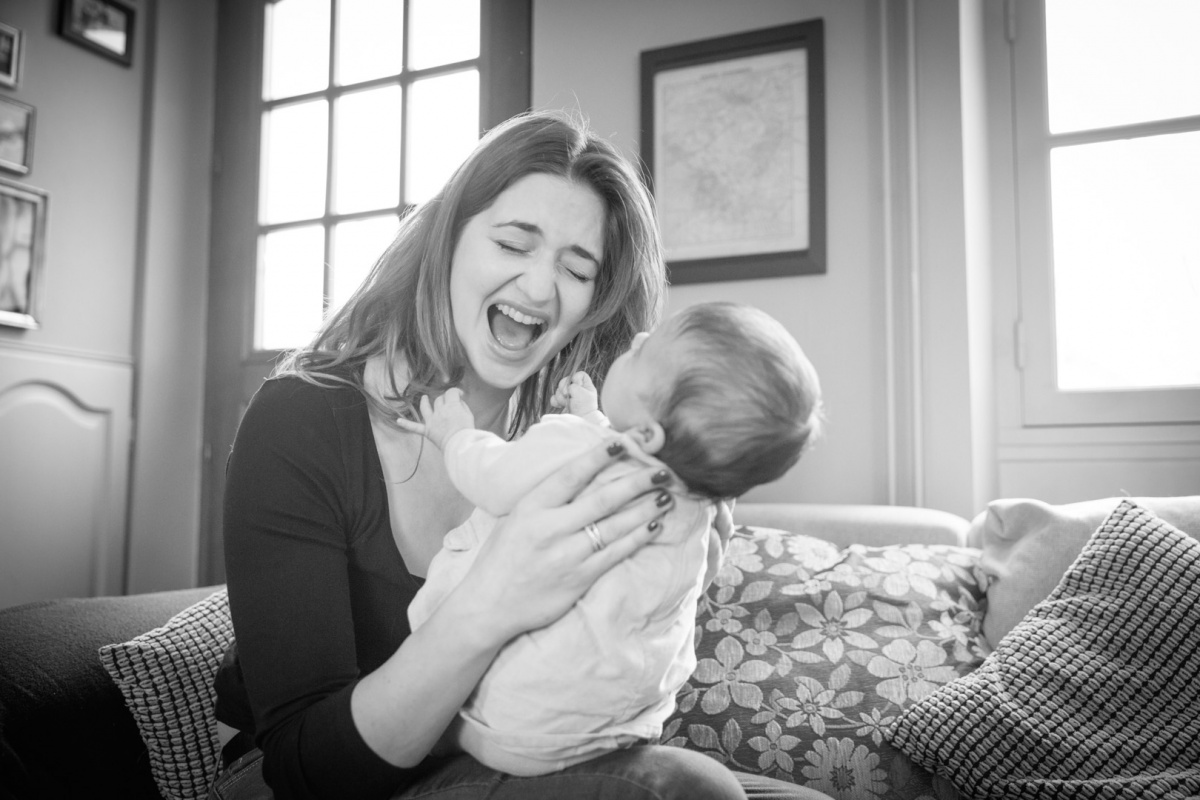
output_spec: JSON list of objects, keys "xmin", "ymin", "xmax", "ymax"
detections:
[{"xmin": 662, "ymin": 527, "xmax": 986, "ymax": 800}]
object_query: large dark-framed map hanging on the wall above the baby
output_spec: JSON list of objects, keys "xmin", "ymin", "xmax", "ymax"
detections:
[{"xmin": 641, "ymin": 19, "xmax": 826, "ymax": 283}]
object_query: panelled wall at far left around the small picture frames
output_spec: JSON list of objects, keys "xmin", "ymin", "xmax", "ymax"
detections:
[{"xmin": 0, "ymin": 0, "xmax": 216, "ymax": 606}]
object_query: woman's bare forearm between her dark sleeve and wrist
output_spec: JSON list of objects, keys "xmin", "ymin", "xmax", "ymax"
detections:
[{"xmin": 350, "ymin": 587, "xmax": 504, "ymax": 766}]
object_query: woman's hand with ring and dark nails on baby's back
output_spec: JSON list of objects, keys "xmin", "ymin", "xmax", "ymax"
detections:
[{"xmin": 448, "ymin": 440, "xmax": 674, "ymax": 644}]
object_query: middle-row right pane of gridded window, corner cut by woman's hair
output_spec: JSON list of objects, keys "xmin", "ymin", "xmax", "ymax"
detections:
[{"xmin": 404, "ymin": 70, "xmax": 479, "ymax": 203}]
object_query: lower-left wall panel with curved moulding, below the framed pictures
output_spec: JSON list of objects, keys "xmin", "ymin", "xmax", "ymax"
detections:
[{"xmin": 0, "ymin": 351, "xmax": 132, "ymax": 607}]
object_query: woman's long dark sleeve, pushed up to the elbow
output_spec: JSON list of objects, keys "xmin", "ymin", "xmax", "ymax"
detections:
[{"xmin": 224, "ymin": 379, "xmax": 413, "ymax": 800}]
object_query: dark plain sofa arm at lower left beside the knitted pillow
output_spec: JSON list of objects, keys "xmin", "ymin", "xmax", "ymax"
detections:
[{"xmin": 0, "ymin": 587, "xmax": 212, "ymax": 800}]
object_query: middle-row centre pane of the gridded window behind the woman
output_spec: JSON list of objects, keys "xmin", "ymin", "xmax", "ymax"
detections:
[{"xmin": 334, "ymin": 86, "xmax": 402, "ymax": 213}]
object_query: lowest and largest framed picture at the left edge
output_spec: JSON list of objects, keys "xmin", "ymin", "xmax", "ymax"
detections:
[{"xmin": 0, "ymin": 180, "xmax": 47, "ymax": 327}]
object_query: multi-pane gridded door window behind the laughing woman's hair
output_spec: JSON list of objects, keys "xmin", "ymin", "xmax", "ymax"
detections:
[{"xmin": 253, "ymin": 0, "xmax": 481, "ymax": 350}]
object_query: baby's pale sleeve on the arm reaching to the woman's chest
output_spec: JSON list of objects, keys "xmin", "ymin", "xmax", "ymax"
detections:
[{"xmin": 444, "ymin": 414, "xmax": 613, "ymax": 517}]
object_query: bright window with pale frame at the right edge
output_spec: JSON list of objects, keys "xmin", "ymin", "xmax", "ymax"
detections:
[{"xmin": 1010, "ymin": 0, "xmax": 1200, "ymax": 425}]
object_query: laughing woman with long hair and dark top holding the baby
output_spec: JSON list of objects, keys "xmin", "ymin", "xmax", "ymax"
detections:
[{"xmin": 214, "ymin": 107, "xmax": 835, "ymax": 799}]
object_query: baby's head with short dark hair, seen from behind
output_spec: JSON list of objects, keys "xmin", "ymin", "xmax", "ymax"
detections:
[{"xmin": 600, "ymin": 302, "xmax": 821, "ymax": 498}]
